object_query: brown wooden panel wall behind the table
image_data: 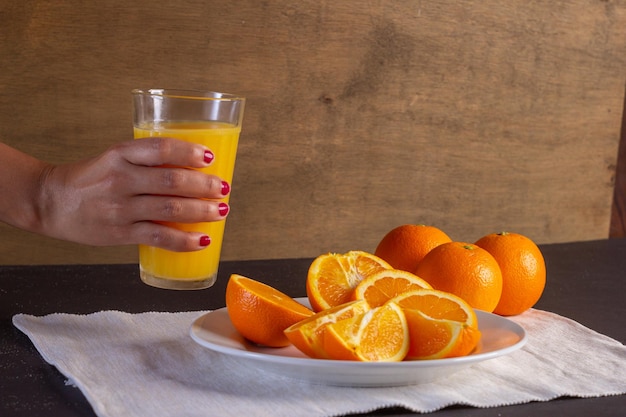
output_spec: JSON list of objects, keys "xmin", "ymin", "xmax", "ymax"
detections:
[{"xmin": 0, "ymin": 0, "xmax": 626, "ymax": 264}]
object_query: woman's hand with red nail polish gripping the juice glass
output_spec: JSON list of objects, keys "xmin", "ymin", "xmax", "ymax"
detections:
[{"xmin": 0, "ymin": 138, "xmax": 230, "ymax": 251}]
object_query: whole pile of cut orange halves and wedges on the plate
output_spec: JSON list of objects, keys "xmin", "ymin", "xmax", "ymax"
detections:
[{"xmin": 226, "ymin": 266, "xmax": 481, "ymax": 362}]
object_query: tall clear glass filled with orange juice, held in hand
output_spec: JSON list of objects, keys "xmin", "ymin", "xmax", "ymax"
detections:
[{"xmin": 132, "ymin": 89, "xmax": 245, "ymax": 290}]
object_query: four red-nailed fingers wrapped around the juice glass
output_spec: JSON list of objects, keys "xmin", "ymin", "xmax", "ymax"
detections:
[{"xmin": 102, "ymin": 138, "xmax": 230, "ymax": 251}]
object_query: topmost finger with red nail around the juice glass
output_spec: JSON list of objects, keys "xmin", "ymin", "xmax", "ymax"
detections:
[{"xmin": 112, "ymin": 137, "xmax": 210, "ymax": 168}]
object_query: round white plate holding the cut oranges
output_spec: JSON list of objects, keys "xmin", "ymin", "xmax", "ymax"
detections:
[{"xmin": 190, "ymin": 298, "xmax": 526, "ymax": 387}]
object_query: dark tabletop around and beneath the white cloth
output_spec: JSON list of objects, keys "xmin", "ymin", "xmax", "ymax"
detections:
[{"xmin": 0, "ymin": 239, "xmax": 626, "ymax": 417}]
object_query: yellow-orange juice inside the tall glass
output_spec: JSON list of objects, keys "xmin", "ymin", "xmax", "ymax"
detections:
[{"xmin": 134, "ymin": 122, "xmax": 241, "ymax": 288}]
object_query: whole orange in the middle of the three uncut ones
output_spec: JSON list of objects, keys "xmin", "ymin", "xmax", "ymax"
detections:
[{"xmin": 415, "ymin": 242, "xmax": 502, "ymax": 312}]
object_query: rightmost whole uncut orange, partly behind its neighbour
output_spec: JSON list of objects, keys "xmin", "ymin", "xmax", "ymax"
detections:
[{"xmin": 476, "ymin": 232, "xmax": 546, "ymax": 316}]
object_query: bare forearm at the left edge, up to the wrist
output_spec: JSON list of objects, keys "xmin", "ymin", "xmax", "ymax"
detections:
[{"xmin": 0, "ymin": 143, "xmax": 50, "ymax": 232}]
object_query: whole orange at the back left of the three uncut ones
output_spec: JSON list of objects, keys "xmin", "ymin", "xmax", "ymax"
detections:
[{"xmin": 374, "ymin": 224, "xmax": 451, "ymax": 272}]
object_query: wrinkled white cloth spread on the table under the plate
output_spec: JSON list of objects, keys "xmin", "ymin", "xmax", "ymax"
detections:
[{"xmin": 13, "ymin": 310, "xmax": 626, "ymax": 417}]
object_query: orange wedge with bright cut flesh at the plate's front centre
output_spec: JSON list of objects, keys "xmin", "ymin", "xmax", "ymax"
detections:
[{"xmin": 324, "ymin": 302, "xmax": 409, "ymax": 362}]
